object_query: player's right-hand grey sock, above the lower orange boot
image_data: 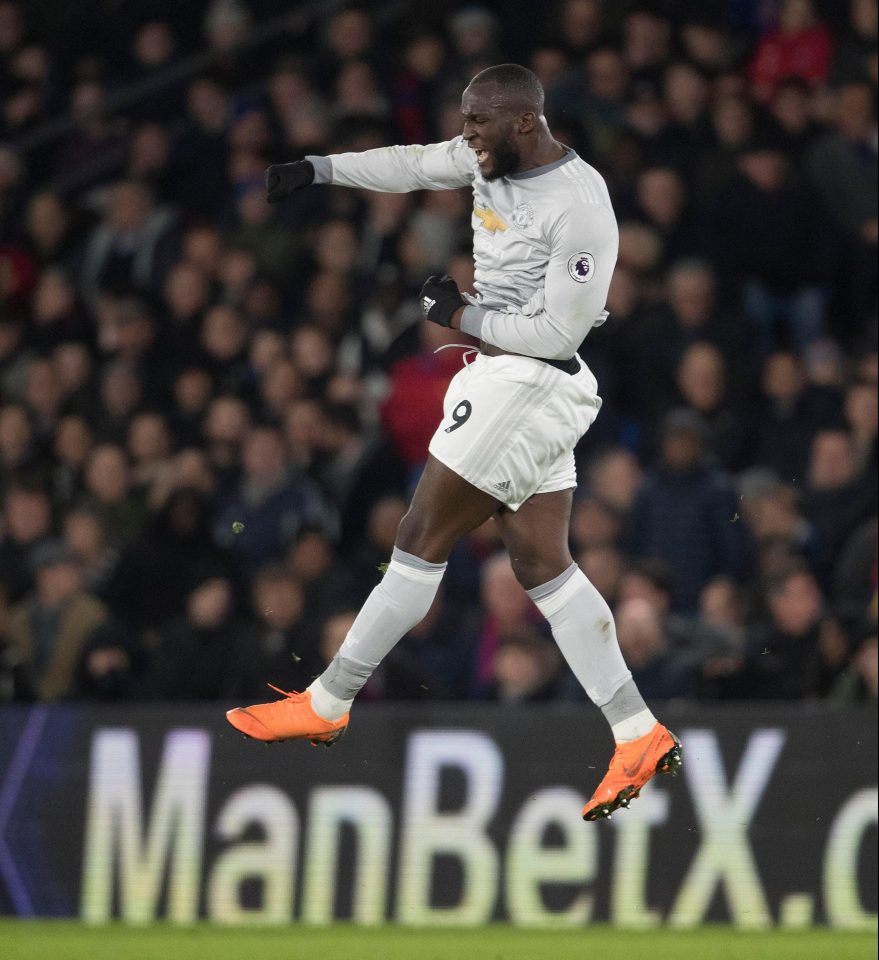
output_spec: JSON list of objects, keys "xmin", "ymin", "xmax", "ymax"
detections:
[{"xmin": 528, "ymin": 563, "xmax": 656, "ymax": 742}]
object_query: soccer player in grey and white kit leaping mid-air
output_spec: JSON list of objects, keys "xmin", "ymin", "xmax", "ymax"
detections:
[{"xmin": 227, "ymin": 64, "xmax": 681, "ymax": 820}]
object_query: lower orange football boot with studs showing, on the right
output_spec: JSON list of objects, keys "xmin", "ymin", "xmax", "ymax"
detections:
[{"xmin": 583, "ymin": 723, "xmax": 683, "ymax": 820}]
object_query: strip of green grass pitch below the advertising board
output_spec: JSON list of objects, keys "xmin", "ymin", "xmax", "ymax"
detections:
[{"xmin": 0, "ymin": 920, "xmax": 876, "ymax": 960}]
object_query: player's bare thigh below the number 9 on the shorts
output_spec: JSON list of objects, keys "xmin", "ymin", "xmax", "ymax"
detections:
[{"xmin": 397, "ymin": 456, "xmax": 500, "ymax": 563}]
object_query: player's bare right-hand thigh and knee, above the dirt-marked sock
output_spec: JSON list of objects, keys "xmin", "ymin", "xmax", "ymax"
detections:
[{"xmin": 496, "ymin": 488, "xmax": 574, "ymax": 590}]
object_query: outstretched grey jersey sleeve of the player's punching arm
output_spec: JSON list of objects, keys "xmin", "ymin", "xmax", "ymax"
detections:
[{"xmin": 306, "ymin": 137, "xmax": 476, "ymax": 193}]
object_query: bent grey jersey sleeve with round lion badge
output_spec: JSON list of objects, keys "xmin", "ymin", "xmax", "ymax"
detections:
[{"xmin": 461, "ymin": 203, "xmax": 619, "ymax": 360}]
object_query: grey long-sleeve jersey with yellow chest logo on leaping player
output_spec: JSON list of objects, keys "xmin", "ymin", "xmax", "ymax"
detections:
[{"xmin": 307, "ymin": 137, "xmax": 619, "ymax": 360}]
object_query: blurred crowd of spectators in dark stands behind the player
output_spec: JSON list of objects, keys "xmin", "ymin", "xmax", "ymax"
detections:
[{"xmin": 0, "ymin": 0, "xmax": 877, "ymax": 703}]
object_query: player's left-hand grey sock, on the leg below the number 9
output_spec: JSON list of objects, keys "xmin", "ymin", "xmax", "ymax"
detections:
[{"xmin": 308, "ymin": 548, "xmax": 446, "ymax": 720}]
